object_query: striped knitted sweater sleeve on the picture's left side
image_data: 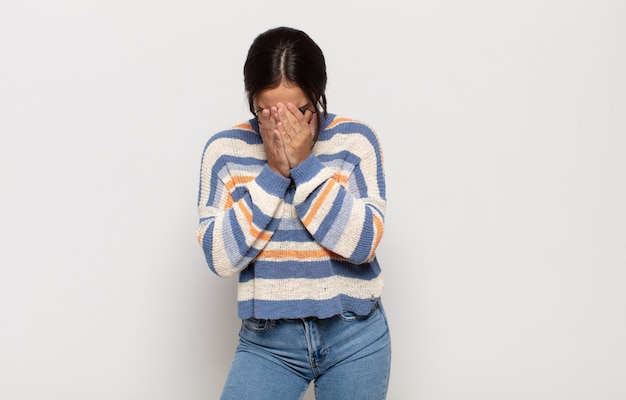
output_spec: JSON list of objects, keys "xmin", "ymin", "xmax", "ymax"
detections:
[{"xmin": 197, "ymin": 130, "xmax": 290, "ymax": 277}]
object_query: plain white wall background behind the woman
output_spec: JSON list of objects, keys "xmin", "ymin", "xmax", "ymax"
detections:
[{"xmin": 0, "ymin": 0, "xmax": 626, "ymax": 400}]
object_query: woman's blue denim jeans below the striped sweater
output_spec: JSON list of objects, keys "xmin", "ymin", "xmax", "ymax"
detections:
[{"xmin": 221, "ymin": 303, "xmax": 391, "ymax": 400}]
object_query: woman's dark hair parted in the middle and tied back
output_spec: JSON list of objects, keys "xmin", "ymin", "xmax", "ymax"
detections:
[{"xmin": 243, "ymin": 27, "xmax": 327, "ymax": 129}]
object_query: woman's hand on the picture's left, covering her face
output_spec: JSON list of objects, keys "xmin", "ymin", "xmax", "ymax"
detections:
[{"xmin": 258, "ymin": 107, "xmax": 291, "ymax": 178}]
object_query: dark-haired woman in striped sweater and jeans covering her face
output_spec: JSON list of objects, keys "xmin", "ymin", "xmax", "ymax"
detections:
[{"xmin": 197, "ymin": 27, "xmax": 391, "ymax": 400}]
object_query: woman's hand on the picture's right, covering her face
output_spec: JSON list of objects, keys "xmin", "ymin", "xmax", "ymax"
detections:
[{"xmin": 276, "ymin": 103, "xmax": 317, "ymax": 169}]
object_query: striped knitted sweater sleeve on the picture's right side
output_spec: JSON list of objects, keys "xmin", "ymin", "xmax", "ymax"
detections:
[{"xmin": 291, "ymin": 121, "xmax": 386, "ymax": 264}]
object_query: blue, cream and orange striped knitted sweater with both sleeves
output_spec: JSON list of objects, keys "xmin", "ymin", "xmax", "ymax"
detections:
[{"xmin": 197, "ymin": 114, "xmax": 386, "ymax": 319}]
